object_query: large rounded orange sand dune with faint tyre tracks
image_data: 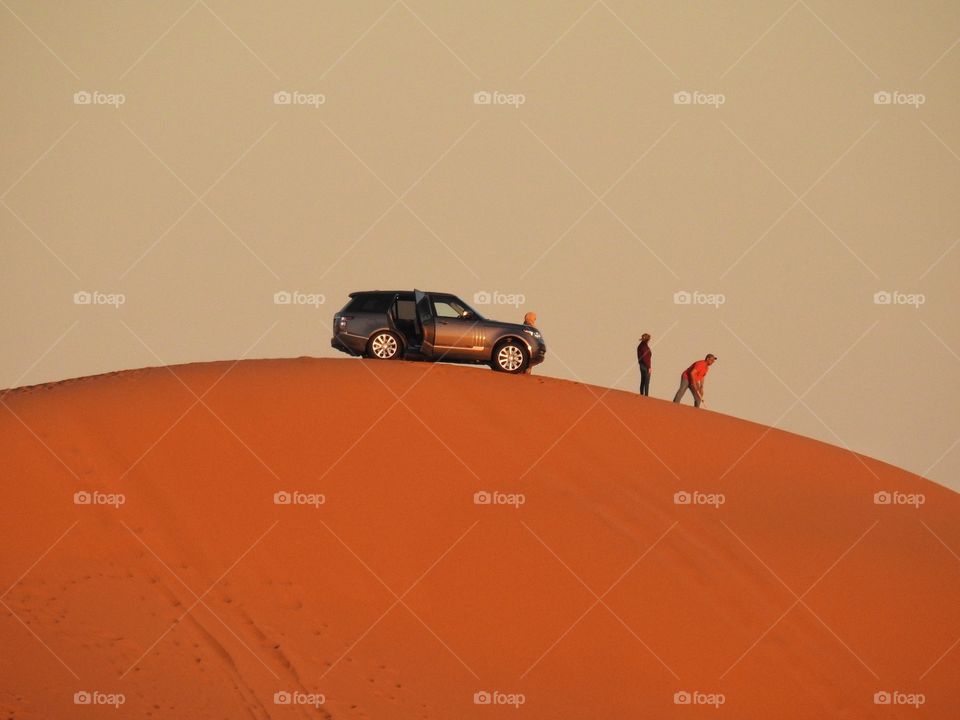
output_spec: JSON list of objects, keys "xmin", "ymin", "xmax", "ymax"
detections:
[{"xmin": 0, "ymin": 358, "xmax": 960, "ymax": 719}]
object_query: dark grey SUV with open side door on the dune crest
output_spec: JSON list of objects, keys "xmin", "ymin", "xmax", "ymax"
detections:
[{"xmin": 330, "ymin": 290, "xmax": 547, "ymax": 374}]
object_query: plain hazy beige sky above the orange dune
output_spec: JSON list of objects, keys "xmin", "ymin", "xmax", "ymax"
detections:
[{"xmin": 0, "ymin": 0, "xmax": 960, "ymax": 489}]
